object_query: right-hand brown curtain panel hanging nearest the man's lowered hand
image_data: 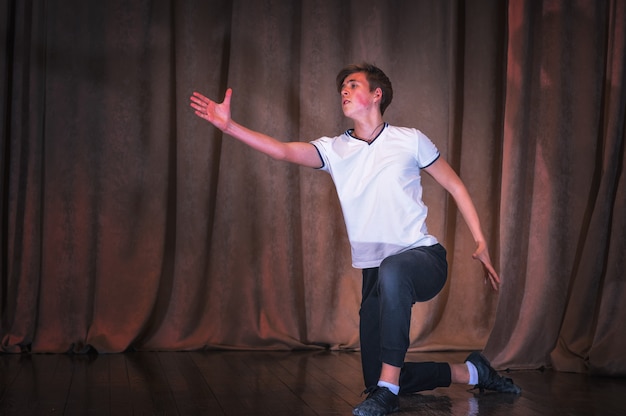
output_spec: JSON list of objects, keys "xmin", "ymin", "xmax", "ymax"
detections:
[{"xmin": 486, "ymin": 1, "xmax": 626, "ymax": 375}]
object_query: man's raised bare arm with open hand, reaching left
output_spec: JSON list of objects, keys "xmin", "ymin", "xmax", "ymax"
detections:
[{"xmin": 190, "ymin": 88, "xmax": 322, "ymax": 168}]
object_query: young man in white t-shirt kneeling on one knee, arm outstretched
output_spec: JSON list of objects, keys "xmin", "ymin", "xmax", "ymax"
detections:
[{"xmin": 191, "ymin": 64, "xmax": 520, "ymax": 416}]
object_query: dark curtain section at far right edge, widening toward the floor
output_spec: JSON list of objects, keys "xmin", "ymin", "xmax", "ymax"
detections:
[{"xmin": 552, "ymin": 1, "xmax": 626, "ymax": 375}]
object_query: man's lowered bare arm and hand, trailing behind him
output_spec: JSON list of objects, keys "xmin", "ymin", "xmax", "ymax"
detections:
[{"xmin": 425, "ymin": 157, "xmax": 500, "ymax": 290}]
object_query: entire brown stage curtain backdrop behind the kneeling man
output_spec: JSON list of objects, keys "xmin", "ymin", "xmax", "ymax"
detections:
[{"xmin": 0, "ymin": 0, "xmax": 626, "ymax": 374}]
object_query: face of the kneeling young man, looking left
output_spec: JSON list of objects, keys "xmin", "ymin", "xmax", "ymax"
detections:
[{"xmin": 341, "ymin": 72, "xmax": 381, "ymax": 118}]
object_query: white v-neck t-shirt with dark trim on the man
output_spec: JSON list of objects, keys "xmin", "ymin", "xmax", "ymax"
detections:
[{"xmin": 311, "ymin": 124, "xmax": 439, "ymax": 269}]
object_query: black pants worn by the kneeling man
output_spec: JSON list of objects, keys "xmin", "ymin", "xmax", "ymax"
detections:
[{"xmin": 360, "ymin": 244, "xmax": 451, "ymax": 394}]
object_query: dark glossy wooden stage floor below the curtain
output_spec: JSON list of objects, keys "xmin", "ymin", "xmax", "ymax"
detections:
[{"xmin": 0, "ymin": 351, "xmax": 626, "ymax": 416}]
